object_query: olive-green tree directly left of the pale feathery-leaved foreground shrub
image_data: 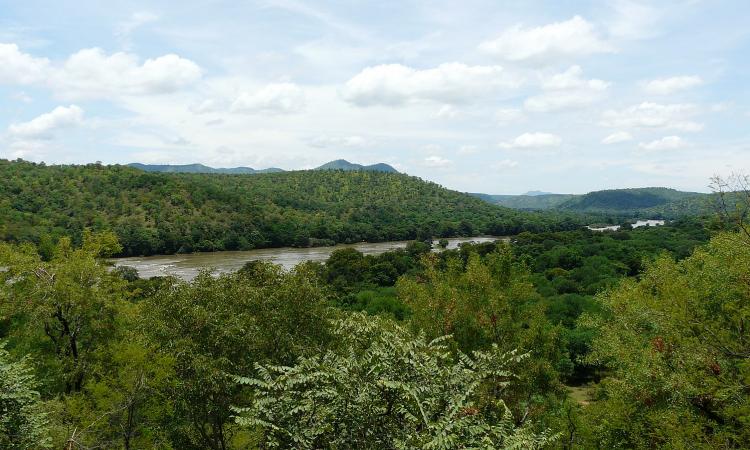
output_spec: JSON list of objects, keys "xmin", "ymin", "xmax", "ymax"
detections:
[{"xmin": 145, "ymin": 263, "xmax": 328, "ymax": 449}]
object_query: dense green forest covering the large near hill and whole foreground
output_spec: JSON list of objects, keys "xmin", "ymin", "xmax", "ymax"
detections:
[{"xmin": 0, "ymin": 163, "xmax": 750, "ymax": 450}]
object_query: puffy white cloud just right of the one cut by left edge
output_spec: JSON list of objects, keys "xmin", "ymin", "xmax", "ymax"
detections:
[{"xmin": 50, "ymin": 48, "xmax": 201, "ymax": 98}]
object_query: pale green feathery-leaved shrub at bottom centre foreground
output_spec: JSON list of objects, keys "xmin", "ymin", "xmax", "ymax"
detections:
[{"xmin": 237, "ymin": 315, "xmax": 554, "ymax": 449}]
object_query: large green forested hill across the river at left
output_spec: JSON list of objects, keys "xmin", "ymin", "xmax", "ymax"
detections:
[{"xmin": 0, "ymin": 160, "xmax": 580, "ymax": 255}]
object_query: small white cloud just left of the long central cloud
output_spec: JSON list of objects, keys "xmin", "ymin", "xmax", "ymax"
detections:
[{"xmin": 231, "ymin": 83, "xmax": 305, "ymax": 114}]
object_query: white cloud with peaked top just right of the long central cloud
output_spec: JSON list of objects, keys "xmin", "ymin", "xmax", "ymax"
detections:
[{"xmin": 524, "ymin": 66, "xmax": 609, "ymax": 112}]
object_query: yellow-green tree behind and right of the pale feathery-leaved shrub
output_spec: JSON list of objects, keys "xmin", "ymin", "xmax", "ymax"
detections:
[{"xmin": 396, "ymin": 243, "xmax": 571, "ymax": 424}]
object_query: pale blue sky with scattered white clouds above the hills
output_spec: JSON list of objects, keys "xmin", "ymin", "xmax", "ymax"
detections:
[{"xmin": 0, "ymin": 0, "xmax": 750, "ymax": 194}]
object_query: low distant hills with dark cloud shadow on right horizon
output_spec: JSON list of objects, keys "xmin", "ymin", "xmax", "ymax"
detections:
[{"xmin": 473, "ymin": 188, "xmax": 715, "ymax": 218}]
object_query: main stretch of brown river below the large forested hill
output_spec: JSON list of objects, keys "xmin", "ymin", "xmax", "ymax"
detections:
[{"xmin": 111, "ymin": 236, "xmax": 507, "ymax": 280}]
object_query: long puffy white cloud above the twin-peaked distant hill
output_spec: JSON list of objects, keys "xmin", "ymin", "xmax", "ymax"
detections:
[{"xmin": 342, "ymin": 63, "xmax": 521, "ymax": 106}]
